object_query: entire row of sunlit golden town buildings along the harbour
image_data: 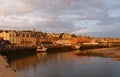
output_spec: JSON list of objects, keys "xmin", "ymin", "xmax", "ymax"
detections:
[{"xmin": 0, "ymin": 30, "xmax": 120, "ymax": 47}]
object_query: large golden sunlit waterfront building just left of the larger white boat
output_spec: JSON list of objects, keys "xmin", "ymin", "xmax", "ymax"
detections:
[{"xmin": 16, "ymin": 31, "xmax": 36, "ymax": 47}]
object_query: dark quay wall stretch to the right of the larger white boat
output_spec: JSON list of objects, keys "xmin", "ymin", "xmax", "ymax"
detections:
[{"xmin": 47, "ymin": 44, "xmax": 120, "ymax": 52}]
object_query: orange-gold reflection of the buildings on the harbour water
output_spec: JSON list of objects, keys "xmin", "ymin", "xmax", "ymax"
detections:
[{"xmin": 8, "ymin": 51, "xmax": 89, "ymax": 70}]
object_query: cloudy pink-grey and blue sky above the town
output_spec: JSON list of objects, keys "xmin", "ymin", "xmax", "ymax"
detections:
[{"xmin": 0, "ymin": 0, "xmax": 120, "ymax": 37}]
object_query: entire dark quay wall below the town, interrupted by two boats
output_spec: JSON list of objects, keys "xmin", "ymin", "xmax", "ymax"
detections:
[{"xmin": 0, "ymin": 44, "xmax": 120, "ymax": 57}]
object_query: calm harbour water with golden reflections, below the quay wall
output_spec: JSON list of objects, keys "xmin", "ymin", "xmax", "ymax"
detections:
[{"xmin": 9, "ymin": 49, "xmax": 120, "ymax": 77}]
